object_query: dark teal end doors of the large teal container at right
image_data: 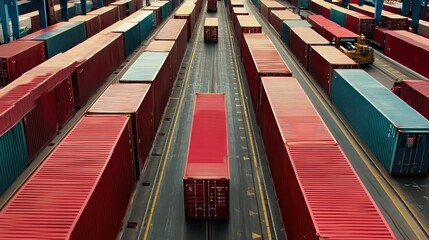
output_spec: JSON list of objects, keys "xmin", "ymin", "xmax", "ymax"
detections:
[{"xmin": 392, "ymin": 133, "xmax": 429, "ymax": 174}]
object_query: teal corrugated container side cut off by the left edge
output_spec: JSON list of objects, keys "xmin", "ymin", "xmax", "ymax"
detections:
[{"xmin": 0, "ymin": 121, "xmax": 28, "ymax": 195}]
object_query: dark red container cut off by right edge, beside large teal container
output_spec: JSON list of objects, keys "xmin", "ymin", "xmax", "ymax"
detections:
[{"xmin": 400, "ymin": 80, "xmax": 429, "ymax": 119}]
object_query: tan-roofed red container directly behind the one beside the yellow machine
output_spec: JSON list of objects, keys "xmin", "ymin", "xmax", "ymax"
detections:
[{"xmin": 290, "ymin": 28, "xmax": 329, "ymax": 70}]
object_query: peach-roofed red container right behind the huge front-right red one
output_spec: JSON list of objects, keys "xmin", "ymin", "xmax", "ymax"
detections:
[{"xmin": 241, "ymin": 34, "xmax": 292, "ymax": 116}]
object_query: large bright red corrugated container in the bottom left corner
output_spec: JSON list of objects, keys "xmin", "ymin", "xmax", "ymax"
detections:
[{"xmin": 0, "ymin": 116, "xmax": 135, "ymax": 239}]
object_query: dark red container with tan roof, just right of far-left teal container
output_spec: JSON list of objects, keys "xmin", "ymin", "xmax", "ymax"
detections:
[{"xmin": 65, "ymin": 33, "xmax": 124, "ymax": 107}]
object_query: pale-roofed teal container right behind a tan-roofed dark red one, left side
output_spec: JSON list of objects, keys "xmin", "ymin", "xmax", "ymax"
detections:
[{"xmin": 112, "ymin": 22, "xmax": 142, "ymax": 58}]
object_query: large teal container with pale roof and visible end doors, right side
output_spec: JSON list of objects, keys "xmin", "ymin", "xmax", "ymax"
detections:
[{"xmin": 331, "ymin": 69, "xmax": 429, "ymax": 175}]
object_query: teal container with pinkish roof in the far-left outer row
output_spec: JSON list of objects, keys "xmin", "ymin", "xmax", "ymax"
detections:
[{"xmin": 33, "ymin": 22, "xmax": 86, "ymax": 58}]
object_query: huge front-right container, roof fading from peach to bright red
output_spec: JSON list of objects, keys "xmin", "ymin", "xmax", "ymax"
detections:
[{"xmin": 259, "ymin": 77, "xmax": 396, "ymax": 239}]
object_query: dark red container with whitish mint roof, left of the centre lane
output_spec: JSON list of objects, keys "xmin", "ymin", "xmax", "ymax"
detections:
[{"xmin": 120, "ymin": 52, "xmax": 172, "ymax": 129}]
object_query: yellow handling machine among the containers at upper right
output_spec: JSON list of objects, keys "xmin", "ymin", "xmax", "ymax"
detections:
[{"xmin": 335, "ymin": 35, "xmax": 374, "ymax": 65}]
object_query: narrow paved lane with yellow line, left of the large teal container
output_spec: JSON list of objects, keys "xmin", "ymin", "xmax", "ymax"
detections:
[{"xmin": 241, "ymin": 1, "xmax": 427, "ymax": 239}]
